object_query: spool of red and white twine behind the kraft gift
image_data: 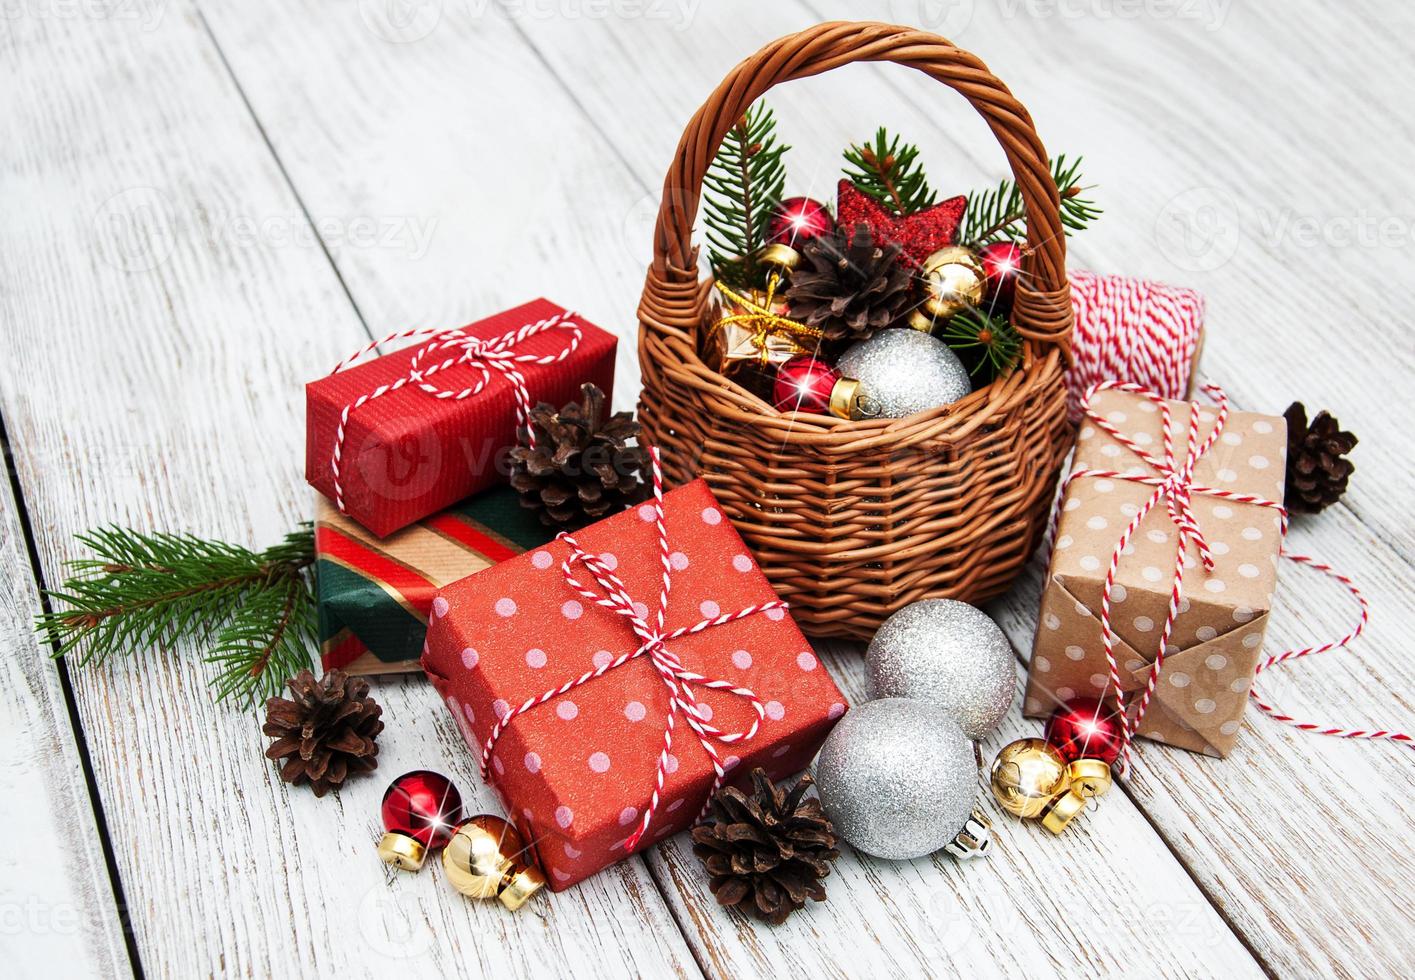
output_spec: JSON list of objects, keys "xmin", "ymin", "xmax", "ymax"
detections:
[{"xmin": 1065, "ymin": 269, "xmax": 1204, "ymax": 421}]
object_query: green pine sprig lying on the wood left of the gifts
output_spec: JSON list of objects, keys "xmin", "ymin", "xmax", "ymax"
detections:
[{"xmin": 35, "ymin": 523, "xmax": 316, "ymax": 704}]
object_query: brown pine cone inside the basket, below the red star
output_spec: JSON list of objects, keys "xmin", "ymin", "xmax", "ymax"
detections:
[{"xmin": 785, "ymin": 222, "xmax": 914, "ymax": 341}]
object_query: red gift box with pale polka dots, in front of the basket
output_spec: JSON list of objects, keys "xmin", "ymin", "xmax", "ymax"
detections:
[{"xmin": 423, "ymin": 479, "xmax": 846, "ymax": 891}]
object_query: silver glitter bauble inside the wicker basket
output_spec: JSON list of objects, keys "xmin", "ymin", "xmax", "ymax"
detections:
[{"xmin": 835, "ymin": 327, "xmax": 972, "ymax": 419}]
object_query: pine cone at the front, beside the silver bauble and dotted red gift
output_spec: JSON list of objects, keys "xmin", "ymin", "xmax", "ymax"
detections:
[{"xmin": 693, "ymin": 769, "xmax": 841, "ymax": 925}]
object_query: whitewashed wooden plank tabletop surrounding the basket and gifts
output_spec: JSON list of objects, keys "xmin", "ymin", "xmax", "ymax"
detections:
[{"xmin": 0, "ymin": 0, "xmax": 1415, "ymax": 976}]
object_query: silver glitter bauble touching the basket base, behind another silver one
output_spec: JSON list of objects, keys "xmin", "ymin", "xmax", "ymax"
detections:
[{"xmin": 865, "ymin": 600, "xmax": 1017, "ymax": 740}]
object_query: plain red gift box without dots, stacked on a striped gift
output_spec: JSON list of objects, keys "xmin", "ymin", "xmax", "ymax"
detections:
[{"xmin": 304, "ymin": 298, "xmax": 617, "ymax": 537}]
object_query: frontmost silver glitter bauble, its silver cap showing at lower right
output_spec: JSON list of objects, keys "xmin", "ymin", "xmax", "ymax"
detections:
[{"xmin": 815, "ymin": 697, "xmax": 978, "ymax": 861}]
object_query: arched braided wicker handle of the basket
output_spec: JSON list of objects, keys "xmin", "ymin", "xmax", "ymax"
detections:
[{"xmin": 640, "ymin": 21, "xmax": 1071, "ymax": 351}]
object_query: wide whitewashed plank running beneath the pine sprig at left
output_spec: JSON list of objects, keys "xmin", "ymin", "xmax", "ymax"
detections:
[{"xmin": 0, "ymin": 6, "xmax": 698, "ymax": 977}]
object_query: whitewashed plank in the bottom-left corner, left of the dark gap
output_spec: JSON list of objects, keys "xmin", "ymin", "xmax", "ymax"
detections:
[{"xmin": 0, "ymin": 469, "xmax": 129, "ymax": 977}]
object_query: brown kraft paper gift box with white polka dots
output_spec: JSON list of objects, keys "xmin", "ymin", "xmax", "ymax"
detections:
[{"xmin": 1023, "ymin": 390, "xmax": 1286, "ymax": 757}]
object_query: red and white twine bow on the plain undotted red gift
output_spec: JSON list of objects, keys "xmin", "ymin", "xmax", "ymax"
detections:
[{"xmin": 330, "ymin": 313, "xmax": 583, "ymax": 512}]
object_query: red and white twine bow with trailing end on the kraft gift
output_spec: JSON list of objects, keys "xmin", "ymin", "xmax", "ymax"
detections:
[{"xmin": 1050, "ymin": 380, "xmax": 1392, "ymax": 772}]
